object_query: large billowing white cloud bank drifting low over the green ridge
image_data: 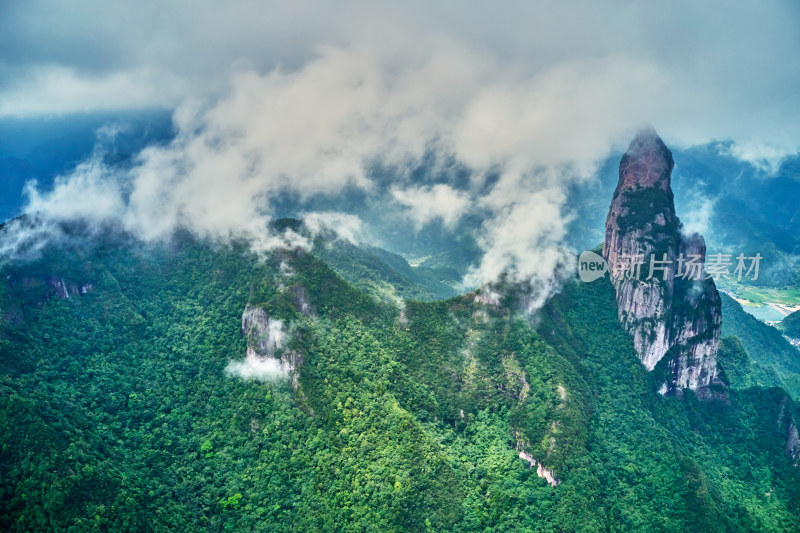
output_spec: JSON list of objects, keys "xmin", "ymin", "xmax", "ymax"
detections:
[{"xmin": 0, "ymin": 42, "xmax": 752, "ymax": 284}]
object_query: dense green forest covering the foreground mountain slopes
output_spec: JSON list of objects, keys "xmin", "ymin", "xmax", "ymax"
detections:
[{"xmin": 0, "ymin": 231, "xmax": 800, "ymax": 532}]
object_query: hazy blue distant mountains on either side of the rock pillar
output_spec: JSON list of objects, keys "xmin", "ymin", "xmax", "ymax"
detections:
[{"xmin": 567, "ymin": 142, "xmax": 800, "ymax": 290}]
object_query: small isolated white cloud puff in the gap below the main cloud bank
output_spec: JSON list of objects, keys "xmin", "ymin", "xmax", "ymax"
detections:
[{"xmin": 391, "ymin": 183, "xmax": 471, "ymax": 228}]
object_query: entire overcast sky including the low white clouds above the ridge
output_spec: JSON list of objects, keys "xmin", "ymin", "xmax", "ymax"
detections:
[{"xmin": 0, "ymin": 0, "xmax": 800, "ymax": 285}]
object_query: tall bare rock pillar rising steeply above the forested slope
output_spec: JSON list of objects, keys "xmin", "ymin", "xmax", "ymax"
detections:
[{"xmin": 603, "ymin": 130, "xmax": 722, "ymax": 394}]
